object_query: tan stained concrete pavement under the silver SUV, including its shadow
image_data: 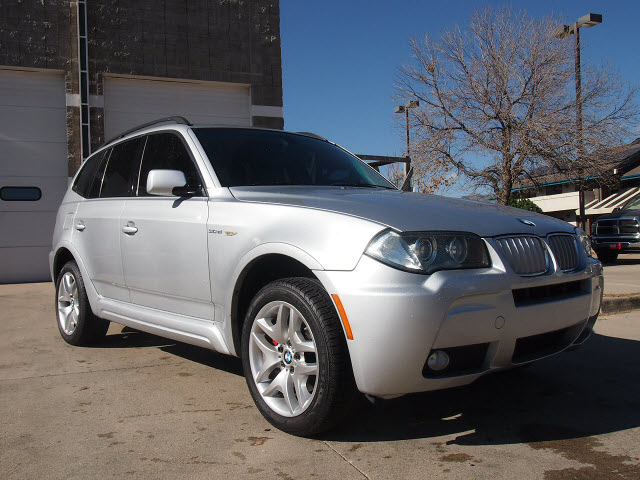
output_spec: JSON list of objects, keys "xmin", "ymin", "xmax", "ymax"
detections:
[{"xmin": 0, "ymin": 284, "xmax": 640, "ymax": 480}]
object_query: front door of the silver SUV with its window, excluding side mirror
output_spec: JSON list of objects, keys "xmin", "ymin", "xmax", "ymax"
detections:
[{"xmin": 120, "ymin": 132, "xmax": 213, "ymax": 320}]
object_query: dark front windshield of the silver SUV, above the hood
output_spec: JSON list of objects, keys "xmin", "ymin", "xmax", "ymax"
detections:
[{"xmin": 194, "ymin": 128, "xmax": 395, "ymax": 190}]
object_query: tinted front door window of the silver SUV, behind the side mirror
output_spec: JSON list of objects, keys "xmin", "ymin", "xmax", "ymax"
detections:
[{"xmin": 138, "ymin": 133, "xmax": 202, "ymax": 197}]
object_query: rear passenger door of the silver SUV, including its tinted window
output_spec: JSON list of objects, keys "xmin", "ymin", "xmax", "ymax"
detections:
[{"xmin": 72, "ymin": 137, "xmax": 145, "ymax": 301}]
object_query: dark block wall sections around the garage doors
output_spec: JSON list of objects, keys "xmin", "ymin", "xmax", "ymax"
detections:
[{"xmin": 0, "ymin": 0, "xmax": 284, "ymax": 174}]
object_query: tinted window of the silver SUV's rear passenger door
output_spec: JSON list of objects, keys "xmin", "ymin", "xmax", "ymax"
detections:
[{"xmin": 100, "ymin": 137, "xmax": 144, "ymax": 198}]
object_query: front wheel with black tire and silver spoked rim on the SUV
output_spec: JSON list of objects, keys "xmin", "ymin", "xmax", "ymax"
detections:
[{"xmin": 242, "ymin": 278, "xmax": 357, "ymax": 436}]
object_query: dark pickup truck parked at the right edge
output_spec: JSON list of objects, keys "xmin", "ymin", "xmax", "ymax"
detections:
[{"xmin": 591, "ymin": 197, "xmax": 640, "ymax": 263}]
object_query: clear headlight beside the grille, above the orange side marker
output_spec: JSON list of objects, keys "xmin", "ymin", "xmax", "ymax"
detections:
[{"xmin": 365, "ymin": 230, "xmax": 491, "ymax": 274}]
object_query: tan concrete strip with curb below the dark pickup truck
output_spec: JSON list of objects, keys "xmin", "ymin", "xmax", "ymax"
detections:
[{"xmin": 602, "ymin": 254, "xmax": 640, "ymax": 314}]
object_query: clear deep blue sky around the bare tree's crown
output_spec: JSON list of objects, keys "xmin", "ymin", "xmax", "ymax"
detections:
[{"xmin": 280, "ymin": 0, "xmax": 640, "ymax": 193}]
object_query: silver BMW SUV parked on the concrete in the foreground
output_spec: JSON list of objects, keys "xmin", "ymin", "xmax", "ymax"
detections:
[{"xmin": 50, "ymin": 119, "xmax": 602, "ymax": 435}]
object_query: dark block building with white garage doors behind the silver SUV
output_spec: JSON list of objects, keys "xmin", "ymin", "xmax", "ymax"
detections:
[{"xmin": 0, "ymin": 0, "xmax": 284, "ymax": 283}]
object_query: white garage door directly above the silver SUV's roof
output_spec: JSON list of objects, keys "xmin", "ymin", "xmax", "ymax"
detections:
[{"xmin": 104, "ymin": 77, "xmax": 251, "ymax": 139}]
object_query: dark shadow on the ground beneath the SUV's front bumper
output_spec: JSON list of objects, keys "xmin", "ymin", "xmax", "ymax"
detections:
[{"xmin": 321, "ymin": 335, "xmax": 640, "ymax": 445}]
